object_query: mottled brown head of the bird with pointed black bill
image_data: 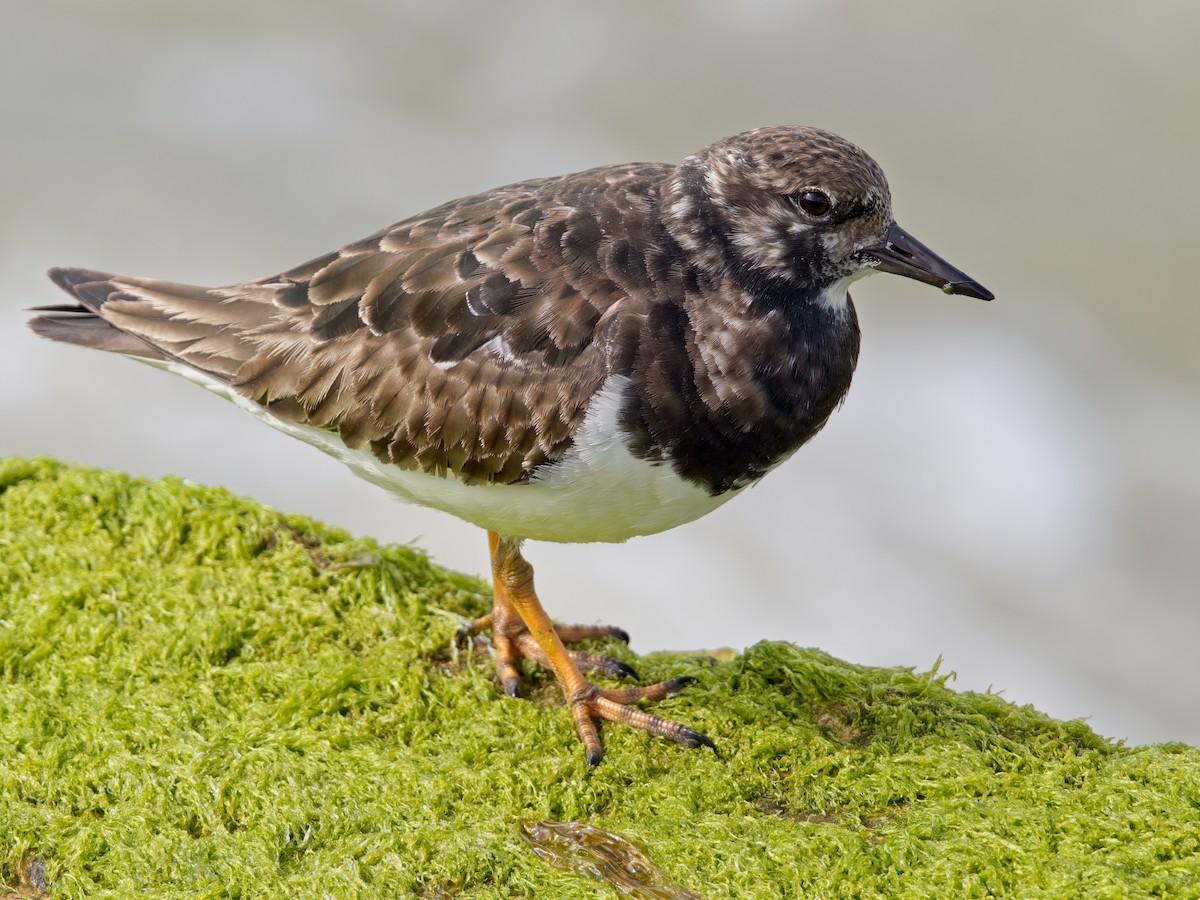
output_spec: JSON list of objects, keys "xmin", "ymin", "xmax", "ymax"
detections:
[{"xmin": 664, "ymin": 127, "xmax": 992, "ymax": 305}]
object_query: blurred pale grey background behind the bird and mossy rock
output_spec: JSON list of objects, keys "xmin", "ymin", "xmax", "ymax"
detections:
[{"xmin": 0, "ymin": 0, "xmax": 1200, "ymax": 744}]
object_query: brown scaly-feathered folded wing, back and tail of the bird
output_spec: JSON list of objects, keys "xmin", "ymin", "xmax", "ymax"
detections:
[{"xmin": 32, "ymin": 166, "xmax": 670, "ymax": 482}]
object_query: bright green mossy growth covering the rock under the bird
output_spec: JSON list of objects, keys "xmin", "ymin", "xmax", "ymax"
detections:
[{"xmin": 0, "ymin": 460, "xmax": 1200, "ymax": 900}]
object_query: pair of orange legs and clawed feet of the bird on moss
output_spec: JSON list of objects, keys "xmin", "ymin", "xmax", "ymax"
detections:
[{"xmin": 473, "ymin": 532, "xmax": 716, "ymax": 766}]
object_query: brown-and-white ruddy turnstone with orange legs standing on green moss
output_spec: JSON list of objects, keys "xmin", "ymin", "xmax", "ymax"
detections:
[{"xmin": 30, "ymin": 127, "xmax": 992, "ymax": 763}]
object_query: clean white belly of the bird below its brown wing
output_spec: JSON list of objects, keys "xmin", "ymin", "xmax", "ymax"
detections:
[{"xmin": 151, "ymin": 362, "xmax": 738, "ymax": 544}]
